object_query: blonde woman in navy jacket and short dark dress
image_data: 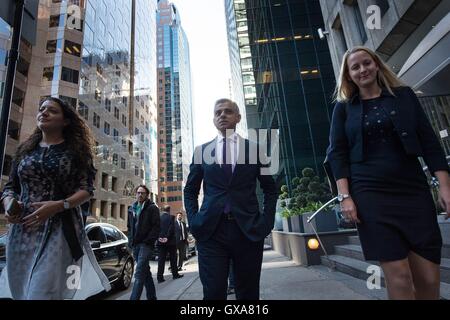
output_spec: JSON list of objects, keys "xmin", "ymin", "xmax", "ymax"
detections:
[{"xmin": 327, "ymin": 47, "xmax": 450, "ymax": 299}]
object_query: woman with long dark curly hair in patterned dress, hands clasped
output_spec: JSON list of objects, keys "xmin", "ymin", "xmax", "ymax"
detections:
[{"xmin": 0, "ymin": 97, "xmax": 110, "ymax": 300}]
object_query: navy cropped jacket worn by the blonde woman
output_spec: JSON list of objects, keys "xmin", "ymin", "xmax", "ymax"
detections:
[{"xmin": 327, "ymin": 87, "xmax": 449, "ymax": 180}]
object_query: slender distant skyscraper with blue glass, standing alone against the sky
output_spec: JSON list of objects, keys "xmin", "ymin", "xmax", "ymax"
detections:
[{"xmin": 157, "ymin": 0, "xmax": 194, "ymax": 212}]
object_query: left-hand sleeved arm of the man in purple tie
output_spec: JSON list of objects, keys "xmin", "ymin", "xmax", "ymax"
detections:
[{"xmin": 184, "ymin": 146, "xmax": 203, "ymax": 221}]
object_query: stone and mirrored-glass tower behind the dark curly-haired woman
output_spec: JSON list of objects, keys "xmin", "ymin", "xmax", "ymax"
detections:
[{"xmin": 0, "ymin": 0, "xmax": 158, "ymax": 230}]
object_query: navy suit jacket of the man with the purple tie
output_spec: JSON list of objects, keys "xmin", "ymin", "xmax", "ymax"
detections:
[{"xmin": 184, "ymin": 138, "xmax": 278, "ymax": 241}]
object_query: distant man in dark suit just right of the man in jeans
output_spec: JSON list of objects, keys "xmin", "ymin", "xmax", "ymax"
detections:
[{"xmin": 157, "ymin": 205, "xmax": 183, "ymax": 283}]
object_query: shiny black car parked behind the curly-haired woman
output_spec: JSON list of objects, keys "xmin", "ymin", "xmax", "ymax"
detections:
[{"xmin": 0, "ymin": 223, "xmax": 134, "ymax": 290}]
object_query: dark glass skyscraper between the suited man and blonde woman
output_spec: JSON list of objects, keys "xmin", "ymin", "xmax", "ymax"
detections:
[{"xmin": 225, "ymin": 0, "xmax": 335, "ymax": 185}]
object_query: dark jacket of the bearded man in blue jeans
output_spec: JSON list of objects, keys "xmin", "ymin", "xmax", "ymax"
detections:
[{"xmin": 127, "ymin": 200, "xmax": 160, "ymax": 247}]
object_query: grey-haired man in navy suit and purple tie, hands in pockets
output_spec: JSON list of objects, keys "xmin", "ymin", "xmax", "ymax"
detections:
[{"xmin": 184, "ymin": 99, "xmax": 278, "ymax": 300}]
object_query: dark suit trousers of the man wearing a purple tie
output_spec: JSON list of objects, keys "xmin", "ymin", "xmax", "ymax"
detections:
[{"xmin": 197, "ymin": 217, "xmax": 264, "ymax": 300}]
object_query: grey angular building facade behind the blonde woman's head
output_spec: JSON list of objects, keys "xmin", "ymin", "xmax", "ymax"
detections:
[{"xmin": 320, "ymin": 0, "xmax": 450, "ymax": 155}]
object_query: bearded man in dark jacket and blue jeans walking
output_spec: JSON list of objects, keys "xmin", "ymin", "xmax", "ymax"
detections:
[{"xmin": 128, "ymin": 185, "xmax": 159, "ymax": 300}]
